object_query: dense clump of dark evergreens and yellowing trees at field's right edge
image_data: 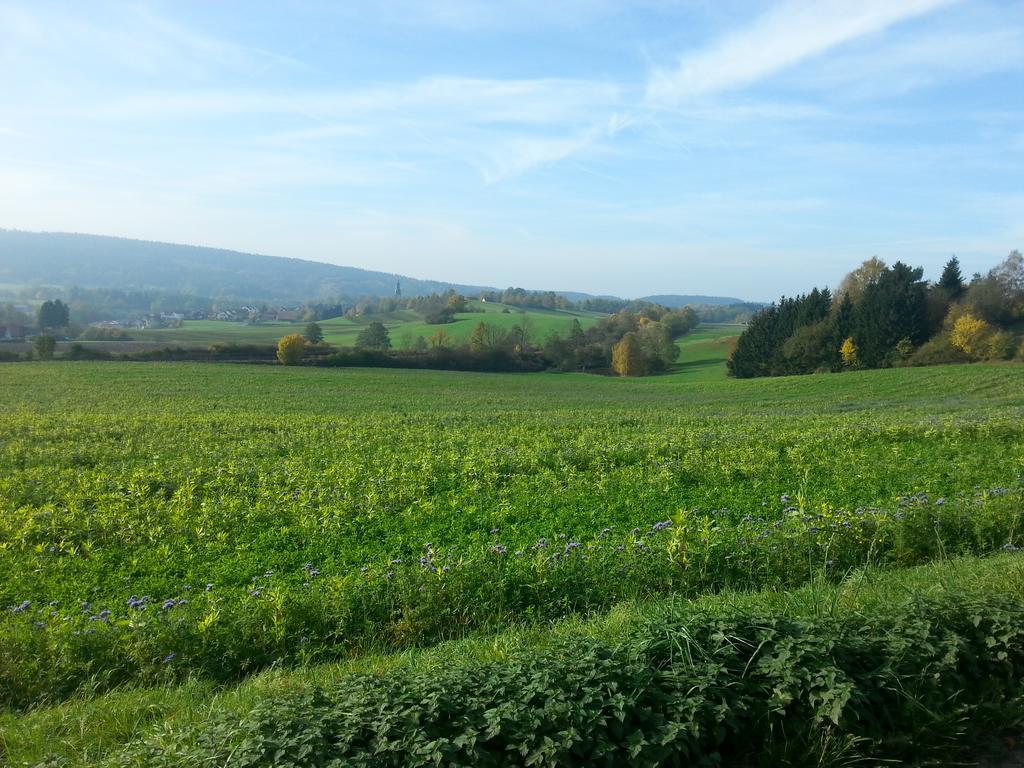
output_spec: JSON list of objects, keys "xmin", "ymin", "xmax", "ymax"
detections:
[{"xmin": 728, "ymin": 251, "xmax": 1024, "ymax": 378}]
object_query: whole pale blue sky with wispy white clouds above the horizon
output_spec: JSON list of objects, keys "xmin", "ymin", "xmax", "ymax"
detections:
[{"xmin": 0, "ymin": 0, "xmax": 1024, "ymax": 299}]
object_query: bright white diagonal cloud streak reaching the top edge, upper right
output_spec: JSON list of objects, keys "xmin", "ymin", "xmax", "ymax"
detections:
[{"xmin": 647, "ymin": 0, "xmax": 955, "ymax": 104}]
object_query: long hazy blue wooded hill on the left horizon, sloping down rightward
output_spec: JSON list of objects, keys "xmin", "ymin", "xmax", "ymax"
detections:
[{"xmin": 0, "ymin": 229, "xmax": 493, "ymax": 302}]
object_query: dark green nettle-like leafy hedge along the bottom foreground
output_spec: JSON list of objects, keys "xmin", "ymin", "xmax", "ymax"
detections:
[{"xmin": 111, "ymin": 593, "xmax": 1024, "ymax": 768}]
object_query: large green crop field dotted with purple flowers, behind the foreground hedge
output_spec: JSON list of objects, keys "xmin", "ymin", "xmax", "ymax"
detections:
[{"xmin": 0, "ymin": 364, "xmax": 1024, "ymax": 709}]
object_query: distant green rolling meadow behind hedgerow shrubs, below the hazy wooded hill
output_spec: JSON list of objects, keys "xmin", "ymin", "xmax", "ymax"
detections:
[{"xmin": 130, "ymin": 301, "xmax": 604, "ymax": 348}]
